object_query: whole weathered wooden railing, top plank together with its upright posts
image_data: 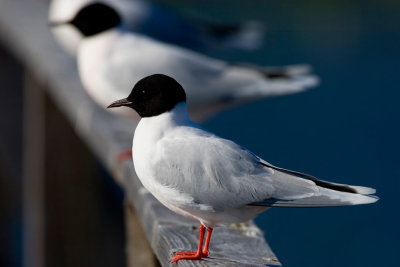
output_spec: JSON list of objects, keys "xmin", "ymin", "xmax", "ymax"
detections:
[{"xmin": 0, "ymin": 0, "xmax": 280, "ymax": 267}]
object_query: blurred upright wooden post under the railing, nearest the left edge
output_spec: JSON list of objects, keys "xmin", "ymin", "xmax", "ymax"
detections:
[{"xmin": 22, "ymin": 74, "xmax": 45, "ymax": 267}]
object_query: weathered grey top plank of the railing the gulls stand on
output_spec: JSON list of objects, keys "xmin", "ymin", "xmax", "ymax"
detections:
[{"xmin": 0, "ymin": 0, "xmax": 280, "ymax": 266}]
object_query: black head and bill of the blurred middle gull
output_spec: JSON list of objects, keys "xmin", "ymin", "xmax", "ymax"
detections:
[{"xmin": 59, "ymin": 3, "xmax": 121, "ymax": 36}]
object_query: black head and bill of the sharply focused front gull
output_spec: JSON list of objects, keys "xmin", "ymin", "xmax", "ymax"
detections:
[{"xmin": 108, "ymin": 74, "xmax": 186, "ymax": 117}]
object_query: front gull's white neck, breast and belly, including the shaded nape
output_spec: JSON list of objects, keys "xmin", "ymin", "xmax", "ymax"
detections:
[{"xmin": 132, "ymin": 103, "xmax": 265, "ymax": 227}]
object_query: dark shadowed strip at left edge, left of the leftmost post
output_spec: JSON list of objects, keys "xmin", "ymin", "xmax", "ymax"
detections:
[{"xmin": 0, "ymin": 43, "xmax": 23, "ymax": 267}]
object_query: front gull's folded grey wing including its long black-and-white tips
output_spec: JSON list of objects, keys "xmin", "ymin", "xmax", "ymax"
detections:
[{"xmin": 155, "ymin": 127, "xmax": 378, "ymax": 210}]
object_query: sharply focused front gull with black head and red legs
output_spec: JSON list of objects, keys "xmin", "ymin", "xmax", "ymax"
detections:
[{"xmin": 109, "ymin": 74, "xmax": 378, "ymax": 262}]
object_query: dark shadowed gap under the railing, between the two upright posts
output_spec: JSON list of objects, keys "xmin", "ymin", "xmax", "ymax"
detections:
[{"xmin": 45, "ymin": 86, "xmax": 126, "ymax": 267}]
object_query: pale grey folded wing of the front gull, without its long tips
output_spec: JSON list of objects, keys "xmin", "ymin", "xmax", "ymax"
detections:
[{"xmin": 154, "ymin": 127, "xmax": 318, "ymax": 210}]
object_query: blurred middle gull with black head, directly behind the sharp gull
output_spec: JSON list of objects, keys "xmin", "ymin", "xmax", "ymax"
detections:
[{"xmin": 51, "ymin": 3, "xmax": 318, "ymax": 120}]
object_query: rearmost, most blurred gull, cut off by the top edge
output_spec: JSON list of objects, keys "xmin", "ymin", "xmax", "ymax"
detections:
[{"xmin": 49, "ymin": 0, "xmax": 264, "ymax": 55}]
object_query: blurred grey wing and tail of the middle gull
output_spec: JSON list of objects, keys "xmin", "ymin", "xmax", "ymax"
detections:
[{"xmin": 103, "ymin": 33, "xmax": 318, "ymax": 115}]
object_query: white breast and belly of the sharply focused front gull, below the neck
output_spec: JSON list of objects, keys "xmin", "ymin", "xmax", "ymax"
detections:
[{"xmin": 132, "ymin": 116, "xmax": 266, "ymax": 227}]
